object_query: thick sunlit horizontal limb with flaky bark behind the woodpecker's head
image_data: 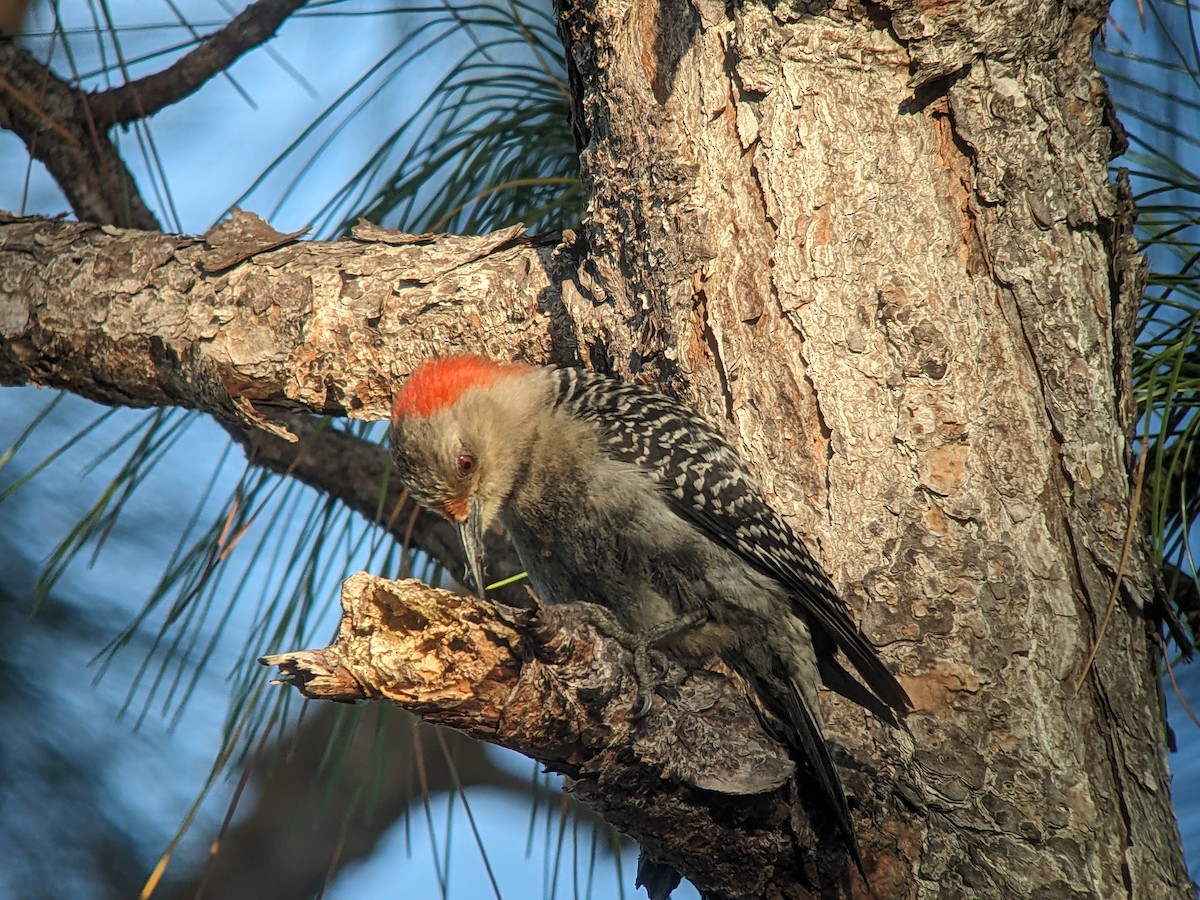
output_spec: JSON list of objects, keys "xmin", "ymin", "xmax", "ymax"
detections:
[{"xmin": 0, "ymin": 214, "xmax": 574, "ymax": 436}]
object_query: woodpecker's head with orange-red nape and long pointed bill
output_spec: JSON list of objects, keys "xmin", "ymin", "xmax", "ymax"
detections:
[{"xmin": 391, "ymin": 355, "xmax": 536, "ymax": 595}]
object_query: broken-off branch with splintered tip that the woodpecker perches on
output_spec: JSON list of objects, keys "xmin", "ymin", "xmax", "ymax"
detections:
[{"xmin": 262, "ymin": 574, "xmax": 907, "ymax": 896}]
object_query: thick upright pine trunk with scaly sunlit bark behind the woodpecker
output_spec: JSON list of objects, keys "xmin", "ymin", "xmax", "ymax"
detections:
[{"xmin": 552, "ymin": 1, "xmax": 1190, "ymax": 898}]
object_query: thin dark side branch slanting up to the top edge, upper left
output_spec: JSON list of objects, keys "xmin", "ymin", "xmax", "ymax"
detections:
[{"xmin": 89, "ymin": 0, "xmax": 306, "ymax": 128}]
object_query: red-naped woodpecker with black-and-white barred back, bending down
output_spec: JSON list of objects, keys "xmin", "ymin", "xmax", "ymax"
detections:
[{"xmin": 392, "ymin": 355, "xmax": 911, "ymax": 871}]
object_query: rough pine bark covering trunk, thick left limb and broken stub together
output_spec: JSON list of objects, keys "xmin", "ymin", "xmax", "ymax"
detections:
[{"xmin": 0, "ymin": 0, "xmax": 1190, "ymax": 898}]
